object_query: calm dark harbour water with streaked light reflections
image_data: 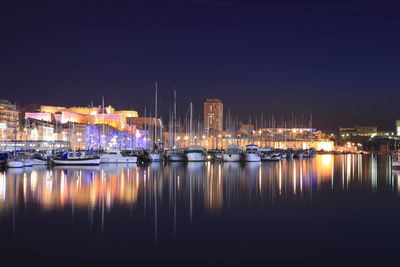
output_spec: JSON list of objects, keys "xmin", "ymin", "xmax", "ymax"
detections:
[{"xmin": 0, "ymin": 155, "xmax": 400, "ymax": 266}]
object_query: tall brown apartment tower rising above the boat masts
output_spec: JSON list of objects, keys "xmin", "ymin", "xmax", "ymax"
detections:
[{"xmin": 204, "ymin": 99, "xmax": 224, "ymax": 134}]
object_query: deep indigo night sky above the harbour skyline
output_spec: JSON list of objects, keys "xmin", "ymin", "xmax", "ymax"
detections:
[{"xmin": 0, "ymin": 0, "xmax": 400, "ymax": 130}]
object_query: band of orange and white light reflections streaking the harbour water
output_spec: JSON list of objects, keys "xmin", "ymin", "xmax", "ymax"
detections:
[{"xmin": 0, "ymin": 155, "xmax": 400, "ymax": 217}]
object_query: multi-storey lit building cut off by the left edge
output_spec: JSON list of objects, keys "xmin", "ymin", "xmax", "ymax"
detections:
[{"xmin": 0, "ymin": 99, "xmax": 19, "ymax": 140}]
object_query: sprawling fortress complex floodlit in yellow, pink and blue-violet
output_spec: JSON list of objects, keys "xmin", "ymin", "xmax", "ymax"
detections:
[{"xmin": 20, "ymin": 106, "xmax": 148, "ymax": 149}]
